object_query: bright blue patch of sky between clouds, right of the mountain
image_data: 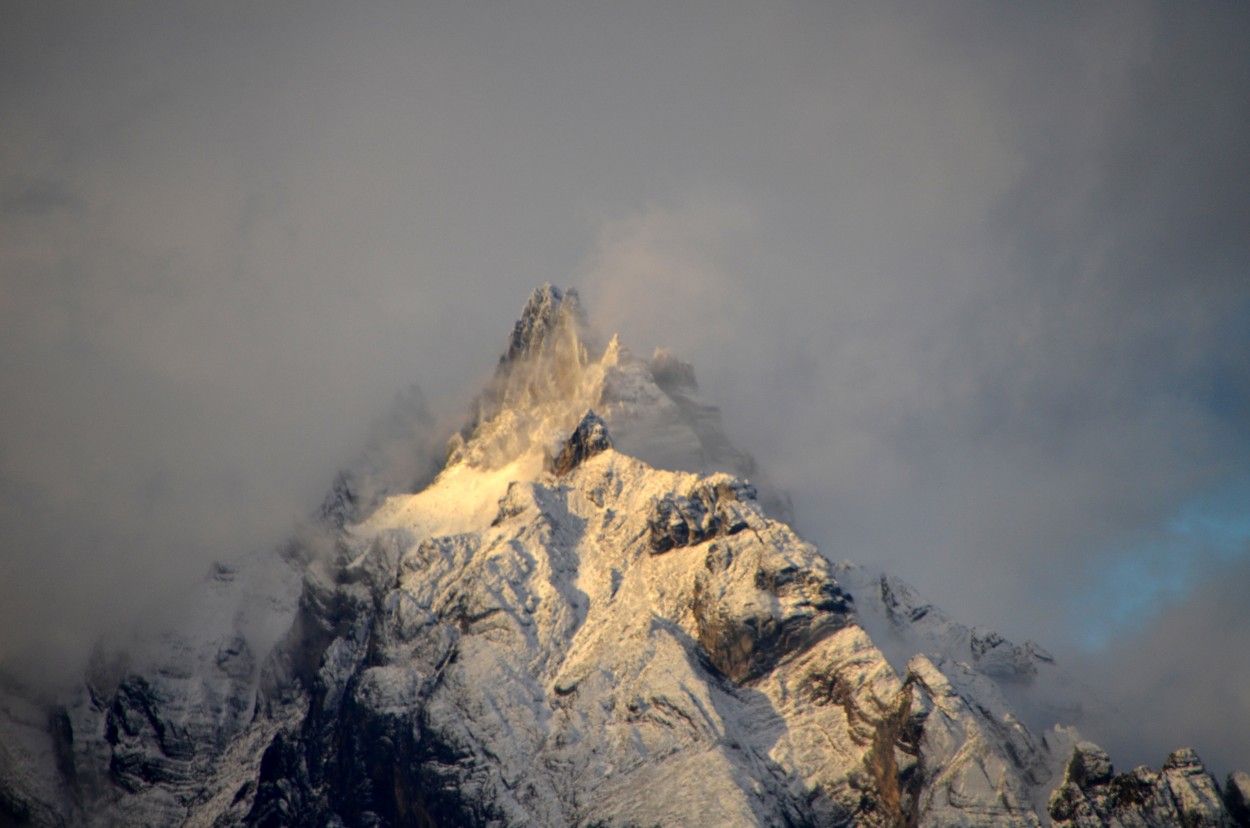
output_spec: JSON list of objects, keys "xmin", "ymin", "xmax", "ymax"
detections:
[{"xmin": 1069, "ymin": 480, "xmax": 1250, "ymax": 652}]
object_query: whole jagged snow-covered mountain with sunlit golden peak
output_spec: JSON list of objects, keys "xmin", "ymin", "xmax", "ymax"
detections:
[{"xmin": 0, "ymin": 285, "xmax": 1250, "ymax": 827}]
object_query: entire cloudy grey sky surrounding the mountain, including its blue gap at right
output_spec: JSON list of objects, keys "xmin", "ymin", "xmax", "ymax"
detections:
[{"xmin": 0, "ymin": 0, "xmax": 1250, "ymax": 770}]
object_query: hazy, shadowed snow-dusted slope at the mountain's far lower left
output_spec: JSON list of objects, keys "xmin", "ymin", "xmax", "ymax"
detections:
[{"xmin": 0, "ymin": 542, "xmax": 299, "ymax": 825}]
